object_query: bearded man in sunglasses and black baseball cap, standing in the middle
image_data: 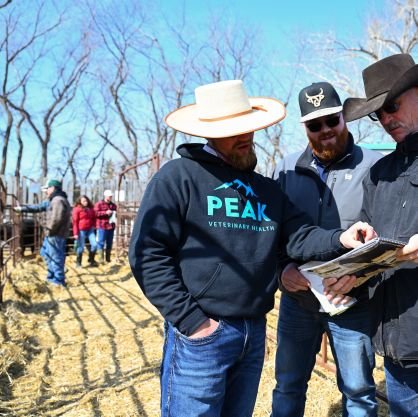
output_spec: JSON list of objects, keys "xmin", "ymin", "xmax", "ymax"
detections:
[{"xmin": 272, "ymin": 82, "xmax": 382, "ymax": 417}]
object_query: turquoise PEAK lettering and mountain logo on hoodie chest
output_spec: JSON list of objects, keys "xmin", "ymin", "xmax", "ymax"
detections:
[{"xmin": 207, "ymin": 179, "xmax": 271, "ymax": 222}]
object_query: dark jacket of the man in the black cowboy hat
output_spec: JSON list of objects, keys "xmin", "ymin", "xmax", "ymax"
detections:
[{"xmin": 361, "ymin": 133, "xmax": 418, "ymax": 366}]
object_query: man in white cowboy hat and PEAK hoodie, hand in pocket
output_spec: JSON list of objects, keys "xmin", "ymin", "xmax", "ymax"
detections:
[{"xmin": 129, "ymin": 80, "xmax": 374, "ymax": 417}]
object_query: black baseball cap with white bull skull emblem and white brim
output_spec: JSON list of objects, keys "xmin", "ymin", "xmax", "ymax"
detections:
[{"xmin": 299, "ymin": 81, "xmax": 343, "ymax": 122}]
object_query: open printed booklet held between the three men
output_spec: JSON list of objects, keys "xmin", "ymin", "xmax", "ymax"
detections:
[{"xmin": 299, "ymin": 237, "xmax": 406, "ymax": 315}]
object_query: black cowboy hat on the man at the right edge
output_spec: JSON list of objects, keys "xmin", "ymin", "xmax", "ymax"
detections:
[{"xmin": 343, "ymin": 54, "xmax": 418, "ymax": 122}]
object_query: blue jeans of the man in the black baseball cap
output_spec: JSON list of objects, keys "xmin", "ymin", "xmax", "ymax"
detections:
[{"xmin": 272, "ymin": 294, "xmax": 377, "ymax": 417}]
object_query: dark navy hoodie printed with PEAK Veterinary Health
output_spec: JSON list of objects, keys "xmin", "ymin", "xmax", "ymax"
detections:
[{"xmin": 129, "ymin": 144, "xmax": 344, "ymax": 336}]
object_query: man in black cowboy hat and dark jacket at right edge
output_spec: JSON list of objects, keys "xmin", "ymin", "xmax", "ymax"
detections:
[{"xmin": 344, "ymin": 54, "xmax": 418, "ymax": 417}]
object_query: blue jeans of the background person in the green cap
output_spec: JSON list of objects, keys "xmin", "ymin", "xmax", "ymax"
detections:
[{"xmin": 41, "ymin": 236, "xmax": 67, "ymax": 285}]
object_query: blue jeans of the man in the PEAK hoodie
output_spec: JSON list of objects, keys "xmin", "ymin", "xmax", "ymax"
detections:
[{"xmin": 161, "ymin": 318, "xmax": 266, "ymax": 417}]
